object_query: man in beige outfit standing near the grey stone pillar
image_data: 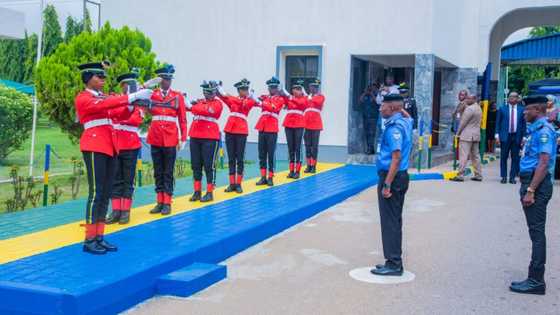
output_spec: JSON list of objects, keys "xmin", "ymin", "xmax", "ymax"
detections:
[{"xmin": 451, "ymin": 95, "xmax": 482, "ymax": 182}]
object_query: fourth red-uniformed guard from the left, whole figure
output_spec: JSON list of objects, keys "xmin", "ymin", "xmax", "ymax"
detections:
[{"xmin": 189, "ymin": 81, "xmax": 223, "ymax": 202}]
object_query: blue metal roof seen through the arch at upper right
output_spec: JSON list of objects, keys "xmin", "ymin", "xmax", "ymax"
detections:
[{"xmin": 501, "ymin": 33, "xmax": 560, "ymax": 63}]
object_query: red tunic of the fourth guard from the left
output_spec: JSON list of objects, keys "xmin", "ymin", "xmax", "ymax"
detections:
[{"xmin": 189, "ymin": 98, "xmax": 223, "ymax": 140}]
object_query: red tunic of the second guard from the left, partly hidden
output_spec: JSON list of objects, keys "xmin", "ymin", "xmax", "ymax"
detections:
[{"xmin": 113, "ymin": 107, "xmax": 144, "ymax": 150}]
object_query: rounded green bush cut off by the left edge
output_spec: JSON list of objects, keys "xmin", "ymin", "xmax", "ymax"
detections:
[{"xmin": 0, "ymin": 85, "xmax": 33, "ymax": 160}]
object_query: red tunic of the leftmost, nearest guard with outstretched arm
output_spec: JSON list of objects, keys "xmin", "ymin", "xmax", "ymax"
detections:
[{"xmin": 75, "ymin": 90, "xmax": 128, "ymax": 156}]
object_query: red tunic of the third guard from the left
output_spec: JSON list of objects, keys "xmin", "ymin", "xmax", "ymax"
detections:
[{"xmin": 147, "ymin": 89, "xmax": 187, "ymax": 147}]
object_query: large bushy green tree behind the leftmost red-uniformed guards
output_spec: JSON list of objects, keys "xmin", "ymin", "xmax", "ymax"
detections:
[{"xmin": 35, "ymin": 23, "xmax": 157, "ymax": 141}]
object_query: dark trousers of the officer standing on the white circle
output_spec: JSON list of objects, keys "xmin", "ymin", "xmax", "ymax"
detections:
[{"xmin": 377, "ymin": 171, "xmax": 409, "ymax": 267}]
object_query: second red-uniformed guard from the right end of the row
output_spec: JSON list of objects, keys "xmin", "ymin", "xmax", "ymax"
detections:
[{"xmin": 283, "ymin": 80, "xmax": 308, "ymax": 179}]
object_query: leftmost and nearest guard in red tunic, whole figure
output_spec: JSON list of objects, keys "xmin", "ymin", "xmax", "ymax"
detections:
[{"xmin": 75, "ymin": 62, "xmax": 152, "ymax": 254}]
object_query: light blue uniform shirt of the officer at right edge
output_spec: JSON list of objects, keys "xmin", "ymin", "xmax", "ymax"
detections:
[{"xmin": 519, "ymin": 117, "xmax": 557, "ymax": 174}]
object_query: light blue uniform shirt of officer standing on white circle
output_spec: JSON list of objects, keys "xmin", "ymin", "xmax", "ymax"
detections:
[{"xmin": 377, "ymin": 113, "xmax": 412, "ymax": 171}]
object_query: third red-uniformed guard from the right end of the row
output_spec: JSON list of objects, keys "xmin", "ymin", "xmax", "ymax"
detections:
[{"xmin": 255, "ymin": 77, "xmax": 288, "ymax": 186}]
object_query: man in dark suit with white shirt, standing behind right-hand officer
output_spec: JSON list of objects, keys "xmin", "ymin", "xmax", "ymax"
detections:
[{"xmin": 496, "ymin": 91, "xmax": 526, "ymax": 184}]
